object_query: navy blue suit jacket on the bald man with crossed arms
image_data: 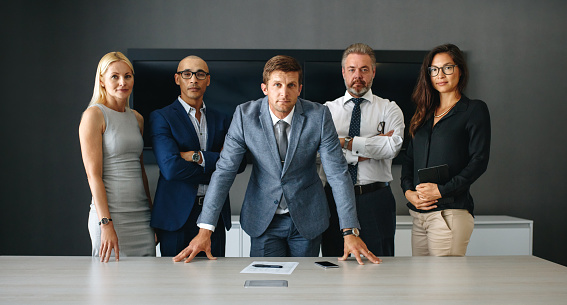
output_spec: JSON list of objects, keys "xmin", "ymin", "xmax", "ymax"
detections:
[{"xmin": 150, "ymin": 100, "xmax": 231, "ymax": 231}]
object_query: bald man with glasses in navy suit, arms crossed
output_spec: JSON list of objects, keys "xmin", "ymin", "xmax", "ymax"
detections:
[{"xmin": 150, "ymin": 56, "xmax": 246, "ymax": 257}]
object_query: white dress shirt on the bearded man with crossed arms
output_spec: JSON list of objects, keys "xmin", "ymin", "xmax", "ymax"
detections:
[{"xmin": 320, "ymin": 90, "xmax": 405, "ymax": 185}]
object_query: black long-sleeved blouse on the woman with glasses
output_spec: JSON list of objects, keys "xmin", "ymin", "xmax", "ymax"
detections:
[{"xmin": 401, "ymin": 95, "xmax": 490, "ymax": 215}]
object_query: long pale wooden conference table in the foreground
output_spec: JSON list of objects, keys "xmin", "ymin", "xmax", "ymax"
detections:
[{"xmin": 0, "ymin": 256, "xmax": 567, "ymax": 305}]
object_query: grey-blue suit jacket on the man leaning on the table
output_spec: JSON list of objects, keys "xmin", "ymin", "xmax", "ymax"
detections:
[{"xmin": 198, "ymin": 97, "xmax": 360, "ymax": 239}]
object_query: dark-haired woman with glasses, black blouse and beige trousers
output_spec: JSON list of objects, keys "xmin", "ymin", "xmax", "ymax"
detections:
[{"xmin": 401, "ymin": 44, "xmax": 490, "ymax": 256}]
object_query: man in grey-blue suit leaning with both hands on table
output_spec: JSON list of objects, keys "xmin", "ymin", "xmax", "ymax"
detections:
[{"xmin": 174, "ymin": 55, "xmax": 381, "ymax": 264}]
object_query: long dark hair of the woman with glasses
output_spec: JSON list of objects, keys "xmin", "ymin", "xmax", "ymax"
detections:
[{"xmin": 409, "ymin": 43, "xmax": 469, "ymax": 137}]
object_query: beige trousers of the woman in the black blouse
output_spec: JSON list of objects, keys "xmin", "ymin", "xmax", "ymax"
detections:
[{"xmin": 410, "ymin": 209, "xmax": 474, "ymax": 256}]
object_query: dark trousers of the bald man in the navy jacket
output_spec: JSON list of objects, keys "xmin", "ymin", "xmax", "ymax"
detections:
[{"xmin": 156, "ymin": 197, "xmax": 226, "ymax": 257}]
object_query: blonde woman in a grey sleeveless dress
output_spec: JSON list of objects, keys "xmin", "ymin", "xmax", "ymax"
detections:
[{"xmin": 79, "ymin": 52, "xmax": 155, "ymax": 262}]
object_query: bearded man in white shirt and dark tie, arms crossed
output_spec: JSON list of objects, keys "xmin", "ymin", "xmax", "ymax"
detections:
[{"xmin": 321, "ymin": 43, "xmax": 404, "ymax": 256}]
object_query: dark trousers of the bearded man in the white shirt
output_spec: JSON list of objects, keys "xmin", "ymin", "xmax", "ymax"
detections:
[{"xmin": 321, "ymin": 185, "xmax": 396, "ymax": 257}]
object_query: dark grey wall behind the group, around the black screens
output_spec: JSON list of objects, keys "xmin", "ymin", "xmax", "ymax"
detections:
[{"xmin": 0, "ymin": 0, "xmax": 567, "ymax": 265}]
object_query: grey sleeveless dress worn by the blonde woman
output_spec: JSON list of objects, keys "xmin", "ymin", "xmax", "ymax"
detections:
[{"xmin": 89, "ymin": 104, "xmax": 156, "ymax": 257}]
